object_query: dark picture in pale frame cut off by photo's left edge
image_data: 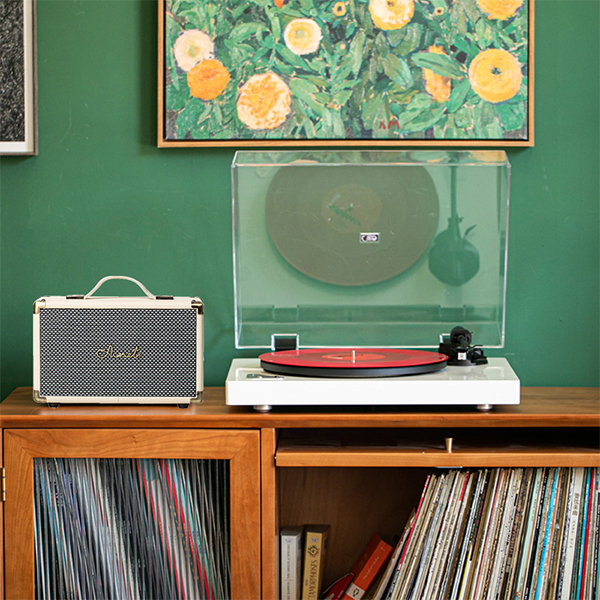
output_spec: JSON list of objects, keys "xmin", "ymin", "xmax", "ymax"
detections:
[{"xmin": 0, "ymin": 0, "xmax": 37, "ymax": 154}]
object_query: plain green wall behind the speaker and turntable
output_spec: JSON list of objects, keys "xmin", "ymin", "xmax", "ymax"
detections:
[{"xmin": 0, "ymin": 0, "xmax": 600, "ymax": 397}]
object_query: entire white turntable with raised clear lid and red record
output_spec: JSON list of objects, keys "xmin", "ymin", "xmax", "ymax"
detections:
[{"xmin": 226, "ymin": 151, "xmax": 520, "ymax": 411}]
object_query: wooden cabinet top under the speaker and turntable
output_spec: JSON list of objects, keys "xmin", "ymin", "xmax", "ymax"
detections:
[{"xmin": 0, "ymin": 387, "xmax": 600, "ymax": 429}]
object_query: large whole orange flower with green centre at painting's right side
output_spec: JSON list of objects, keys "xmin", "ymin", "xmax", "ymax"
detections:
[{"xmin": 469, "ymin": 48, "xmax": 523, "ymax": 103}]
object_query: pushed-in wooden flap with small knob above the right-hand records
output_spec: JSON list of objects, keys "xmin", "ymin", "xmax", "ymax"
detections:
[{"xmin": 275, "ymin": 428, "xmax": 600, "ymax": 467}]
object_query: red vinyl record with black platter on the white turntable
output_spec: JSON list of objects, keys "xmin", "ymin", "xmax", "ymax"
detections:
[{"xmin": 259, "ymin": 348, "xmax": 448, "ymax": 377}]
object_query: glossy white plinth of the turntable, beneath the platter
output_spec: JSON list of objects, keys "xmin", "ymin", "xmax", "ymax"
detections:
[{"xmin": 225, "ymin": 358, "xmax": 520, "ymax": 411}]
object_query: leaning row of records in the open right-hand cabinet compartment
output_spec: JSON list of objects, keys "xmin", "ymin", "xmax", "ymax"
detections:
[{"xmin": 375, "ymin": 468, "xmax": 600, "ymax": 600}]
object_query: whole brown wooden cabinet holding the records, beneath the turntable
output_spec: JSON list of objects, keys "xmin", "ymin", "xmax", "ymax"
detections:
[{"xmin": 0, "ymin": 388, "xmax": 600, "ymax": 600}]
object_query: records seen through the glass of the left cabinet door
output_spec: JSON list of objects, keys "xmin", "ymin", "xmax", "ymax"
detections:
[{"xmin": 34, "ymin": 458, "xmax": 230, "ymax": 600}]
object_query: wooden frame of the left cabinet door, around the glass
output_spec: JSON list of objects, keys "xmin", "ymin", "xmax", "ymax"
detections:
[{"xmin": 4, "ymin": 429, "xmax": 260, "ymax": 600}]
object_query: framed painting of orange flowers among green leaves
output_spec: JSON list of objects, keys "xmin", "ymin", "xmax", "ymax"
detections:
[{"xmin": 158, "ymin": 0, "xmax": 534, "ymax": 147}]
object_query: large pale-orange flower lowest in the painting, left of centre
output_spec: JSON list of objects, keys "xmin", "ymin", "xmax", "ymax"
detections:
[{"xmin": 237, "ymin": 71, "xmax": 292, "ymax": 129}]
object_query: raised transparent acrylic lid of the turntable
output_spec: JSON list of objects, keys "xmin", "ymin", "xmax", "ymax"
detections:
[{"xmin": 232, "ymin": 151, "xmax": 510, "ymax": 348}]
